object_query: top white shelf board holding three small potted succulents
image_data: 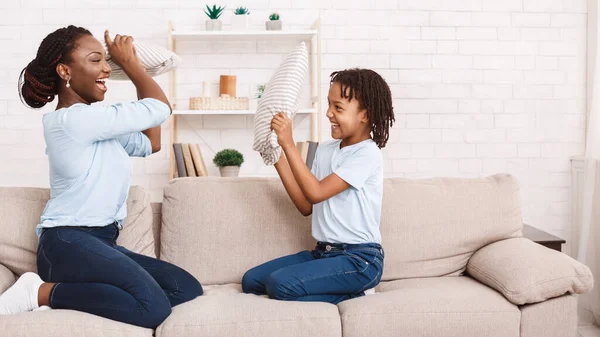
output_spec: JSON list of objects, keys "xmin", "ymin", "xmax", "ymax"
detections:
[{"xmin": 171, "ymin": 30, "xmax": 318, "ymax": 41}]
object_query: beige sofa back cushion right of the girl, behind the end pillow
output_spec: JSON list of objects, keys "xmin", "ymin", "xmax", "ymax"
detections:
[{"xmin": 381, "ymin": 174, "xmax": 522, "ymax": 281}]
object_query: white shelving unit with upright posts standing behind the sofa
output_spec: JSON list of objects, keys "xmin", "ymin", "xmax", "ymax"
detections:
[{"xmin": 168, "ymin": 19, "xmax": 322, "ymax": 179}]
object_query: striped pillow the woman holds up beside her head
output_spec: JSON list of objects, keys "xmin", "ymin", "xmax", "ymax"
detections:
[{"xmin": 102, "ymin": 41, "xmax": 181, "ymax": 80}]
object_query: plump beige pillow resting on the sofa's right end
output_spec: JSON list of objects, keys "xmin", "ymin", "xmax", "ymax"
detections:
[{"xmin": 467, "ymin": 238, "xmax": 594, "ymax": 305}]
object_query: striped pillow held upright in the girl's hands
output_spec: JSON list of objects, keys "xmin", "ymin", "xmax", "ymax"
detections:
[{"xmin": 252, "ymin": 42, "xmax": 308, "ymax": 165}]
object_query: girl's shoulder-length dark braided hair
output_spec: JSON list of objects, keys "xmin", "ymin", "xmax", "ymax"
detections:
[{"xmin": 330, "ymin": 68, "xmax": 396, "ymax": 148}]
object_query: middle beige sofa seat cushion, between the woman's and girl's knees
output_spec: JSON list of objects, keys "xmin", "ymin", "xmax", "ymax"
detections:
[{"xmin": 156, "ymin": 284, "xmax": 342, "ymax": 337}]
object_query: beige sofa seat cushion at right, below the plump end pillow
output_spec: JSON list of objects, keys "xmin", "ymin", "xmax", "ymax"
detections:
[{"xmin": 338, "ymin": 277, "xmax": 521, "ymax": 337}]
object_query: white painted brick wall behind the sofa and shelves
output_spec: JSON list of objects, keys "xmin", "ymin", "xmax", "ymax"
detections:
[{"xmin": 0, "ymin": 0, "xmax": 587, "ymax": 239}]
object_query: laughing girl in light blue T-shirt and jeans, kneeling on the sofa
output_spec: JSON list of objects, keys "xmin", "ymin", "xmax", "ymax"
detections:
[{"xmin": 242, "ymin": 69, "xmax": 394, "ymax": 304}]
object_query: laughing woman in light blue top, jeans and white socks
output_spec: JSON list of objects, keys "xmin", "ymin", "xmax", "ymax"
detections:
[{"xmin": 0, "ymin": 26, "xmax": 202, "ymax": 328}]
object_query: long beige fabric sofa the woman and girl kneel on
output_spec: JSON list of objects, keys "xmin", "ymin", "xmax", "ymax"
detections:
[{"xmin": 0, "ymin": 174, "xmax": 593, "ymax": 337}]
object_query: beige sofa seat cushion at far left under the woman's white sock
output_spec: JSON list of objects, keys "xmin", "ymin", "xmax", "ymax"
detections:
[{"xmin": 0, "ymin": 310, "xmax": 152, "ymax": 337}]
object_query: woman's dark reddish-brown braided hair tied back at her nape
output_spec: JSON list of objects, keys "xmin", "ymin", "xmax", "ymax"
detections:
[{"xmin": 18, "ymin": 25, "xmax": 92, "ymax": 108}]
